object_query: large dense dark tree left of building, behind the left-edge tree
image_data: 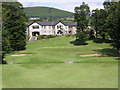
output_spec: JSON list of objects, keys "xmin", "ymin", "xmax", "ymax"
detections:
[{"xmin": 2, "ymin": 2, "xmax": 26, "ymax": 51}]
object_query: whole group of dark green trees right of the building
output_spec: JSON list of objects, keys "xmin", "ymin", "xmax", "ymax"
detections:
[{"xmin": 74, "ymin": 0, "xmax": 120, "ymax": 56}]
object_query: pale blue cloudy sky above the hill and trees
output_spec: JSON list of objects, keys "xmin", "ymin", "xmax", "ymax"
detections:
[{"xmin": 18, "ymin": 0, "xmax": 104, "ymax": 12}]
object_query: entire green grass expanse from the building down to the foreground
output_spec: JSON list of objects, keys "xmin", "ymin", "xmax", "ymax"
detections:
[{"xmin": 2, "ymin": 37, "xmax": 118, "ymax": 88}]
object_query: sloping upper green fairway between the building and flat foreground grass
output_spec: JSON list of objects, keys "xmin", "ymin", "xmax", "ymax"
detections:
[{"xmin": 6, "ymin": 37, "xmax": 117, "ymax": 64}]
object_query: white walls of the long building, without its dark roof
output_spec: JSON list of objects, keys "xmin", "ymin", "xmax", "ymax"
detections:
[{"xmin": 27, "ymin": 22, "xmax": 77, "ymax": 36}]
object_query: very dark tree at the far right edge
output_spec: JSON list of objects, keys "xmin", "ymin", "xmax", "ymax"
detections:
[{"xmin": 104, "ymin": 2, "xmax": 120, "ymax": 56}]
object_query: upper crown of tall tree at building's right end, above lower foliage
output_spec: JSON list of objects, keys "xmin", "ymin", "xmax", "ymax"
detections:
[{"xmin": 74, "ymin": 2, "xmax": 90, "ymax": 31}]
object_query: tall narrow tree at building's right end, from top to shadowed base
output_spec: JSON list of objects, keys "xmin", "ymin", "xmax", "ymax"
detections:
[{"xmin": 74, "ymin": 2, "xmax": 90, "ymax": 44}]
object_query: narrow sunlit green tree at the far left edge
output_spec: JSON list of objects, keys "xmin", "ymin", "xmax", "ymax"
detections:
[{"xmin": 2, "ymin": 5, "xmax": 12, "ymax": 64}]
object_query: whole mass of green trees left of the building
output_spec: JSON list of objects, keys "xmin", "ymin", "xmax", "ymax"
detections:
[{"xmin": 2, "ymin": 2, "xmax": 26, "ymax": 63}]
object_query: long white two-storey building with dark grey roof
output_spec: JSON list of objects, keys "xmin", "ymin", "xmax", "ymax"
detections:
[{"xmin": 26, "ymin": 21, "xmax": 77, "ymax": 37}]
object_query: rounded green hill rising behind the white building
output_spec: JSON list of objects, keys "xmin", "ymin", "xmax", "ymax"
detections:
[{"xmin": 24, "ymin": 7, "xmax": 73, "ymax": 19}]
